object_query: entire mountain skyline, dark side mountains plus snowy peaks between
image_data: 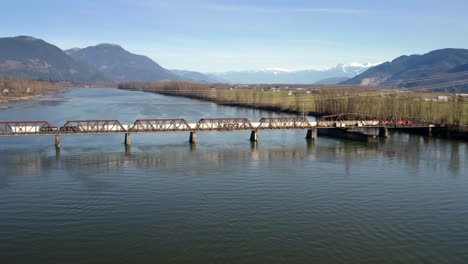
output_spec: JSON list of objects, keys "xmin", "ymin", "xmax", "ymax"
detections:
[{"xmin": 0, "ymin": 36, "xmax": 468, "ymax": 92}]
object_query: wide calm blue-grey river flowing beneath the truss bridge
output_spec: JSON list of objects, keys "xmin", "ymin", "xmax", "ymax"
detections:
[{"xmin": 0, "ymin": 88, "xmax": 468, "ymax": 264}]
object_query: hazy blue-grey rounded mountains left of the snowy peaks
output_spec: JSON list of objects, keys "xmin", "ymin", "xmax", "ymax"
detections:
[{"xmin": 0, "ymin": 36, "xmax": 215, "ymax": 83}]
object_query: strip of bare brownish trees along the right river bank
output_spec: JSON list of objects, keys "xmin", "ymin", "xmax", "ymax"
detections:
[{"xmin": 119, "ymin": 82, "xmax": 468, "ymax": 126}]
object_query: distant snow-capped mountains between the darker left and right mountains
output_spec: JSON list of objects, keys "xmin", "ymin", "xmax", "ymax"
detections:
[{"xmin": 210, "ymin": 62, "xmax": 379, "ymax": 84}]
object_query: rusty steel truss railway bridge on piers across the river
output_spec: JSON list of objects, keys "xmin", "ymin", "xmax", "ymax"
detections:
[{"xmin": 0, "ymin": 114, "xmax": 435, "ymax": 148}]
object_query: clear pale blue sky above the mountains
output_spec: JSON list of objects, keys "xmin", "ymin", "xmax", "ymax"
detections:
[{"xmin": 0, "ymin": 0, "xmax": 468, "ymax": 72}]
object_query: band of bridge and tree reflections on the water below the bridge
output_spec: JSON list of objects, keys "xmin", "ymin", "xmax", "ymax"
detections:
[{"xmin": 0, "ymin": 135, "xmax": 467, "ymax": 187}]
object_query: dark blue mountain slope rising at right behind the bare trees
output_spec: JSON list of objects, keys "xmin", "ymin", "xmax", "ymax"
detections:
[{"xmin": 341, "ymin": 49, "xmax": 468, "ymax": 91}]
